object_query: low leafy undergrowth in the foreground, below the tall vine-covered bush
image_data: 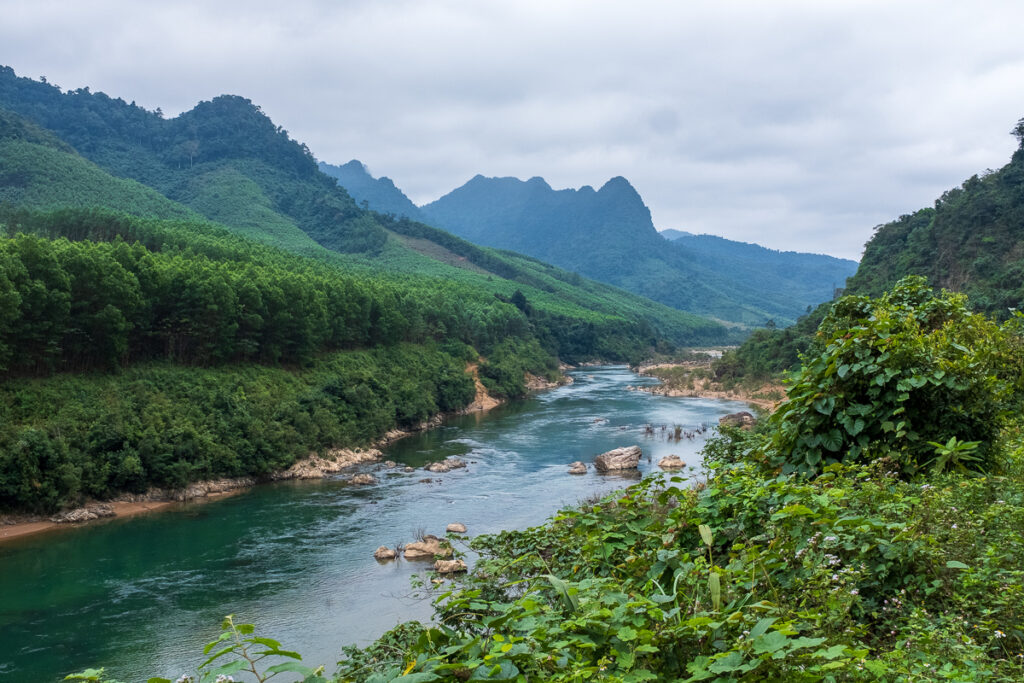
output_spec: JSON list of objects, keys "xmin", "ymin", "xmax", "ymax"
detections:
[{"xmin": 323, "ymin": 434, "xmax": 1024, "ymax": 682}]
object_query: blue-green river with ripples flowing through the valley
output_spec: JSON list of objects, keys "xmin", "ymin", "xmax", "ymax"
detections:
[{"xmin": 0, "ymin": 367, "xmax": 744, "ymax": 683}]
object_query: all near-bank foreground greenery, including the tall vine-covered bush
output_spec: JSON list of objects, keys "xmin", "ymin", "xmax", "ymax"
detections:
[{"xmin": 72, "ymin": 280, "xmax": 1024, "ymax": 683}]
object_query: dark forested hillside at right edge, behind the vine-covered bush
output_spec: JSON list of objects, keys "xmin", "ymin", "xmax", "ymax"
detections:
[{"xmin": 717, "ymin": 119, "xmax": 1024, "ymax": 379}]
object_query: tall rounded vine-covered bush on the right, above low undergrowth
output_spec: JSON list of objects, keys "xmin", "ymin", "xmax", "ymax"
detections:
[{"xmin": 772, "ymin": 276, "xmax": 1022, "ymax": 474}]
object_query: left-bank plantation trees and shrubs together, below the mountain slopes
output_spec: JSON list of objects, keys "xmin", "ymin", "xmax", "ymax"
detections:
[{"xmin": 0, "ymin": 205, "xmax": 679, "ymax": 512}]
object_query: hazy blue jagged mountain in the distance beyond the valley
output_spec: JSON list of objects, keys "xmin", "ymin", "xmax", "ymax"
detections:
[{"xmin": 421, "ymin": 175, "xmax": 854, "ymax": 327}]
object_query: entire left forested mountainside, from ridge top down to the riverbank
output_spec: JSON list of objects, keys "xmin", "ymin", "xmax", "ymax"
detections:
[{"xmin": 0, "ymin": 68, "xmax": 734, "ymax": 512}]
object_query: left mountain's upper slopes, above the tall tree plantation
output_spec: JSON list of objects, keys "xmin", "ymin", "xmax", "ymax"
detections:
[{"xmin": 0, "ymin": 68, "xmax": 735, "ymax": 357}]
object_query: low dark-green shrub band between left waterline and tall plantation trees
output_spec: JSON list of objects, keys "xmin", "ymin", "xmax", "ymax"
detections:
[{"xmin": 0, "ymin": 345, "xmax": 475, "ymax": 512}]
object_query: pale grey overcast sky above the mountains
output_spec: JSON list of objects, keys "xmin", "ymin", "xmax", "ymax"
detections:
[{"xmin": 0, "ymin": 0, "xmax": 1024, "ymax": 258}]
